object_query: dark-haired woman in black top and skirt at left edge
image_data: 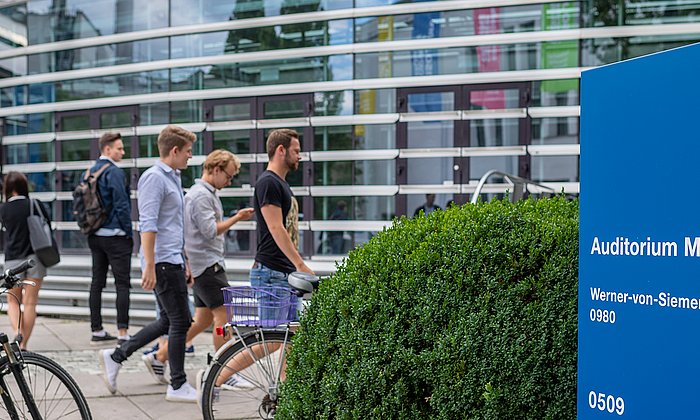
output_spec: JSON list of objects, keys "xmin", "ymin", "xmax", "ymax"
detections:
[{"xmin": 0, "ymin": 172, "xmax": 51, "ymax": 349}]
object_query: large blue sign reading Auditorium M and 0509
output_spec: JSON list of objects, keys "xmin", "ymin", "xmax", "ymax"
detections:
[{"xmin": 577, "ymin": 44, "xmax": 700, "ymax": 419}]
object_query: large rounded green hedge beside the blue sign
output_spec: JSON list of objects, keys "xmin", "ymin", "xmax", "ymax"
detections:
[{"xmin": 278, "ymin": 198, "xmax": 578, "ymax": 419}]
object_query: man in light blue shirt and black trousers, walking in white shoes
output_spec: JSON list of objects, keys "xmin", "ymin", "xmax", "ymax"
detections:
[{"xmin": 100, "ymin": 125, "xmax": 197, "ymax": 402}]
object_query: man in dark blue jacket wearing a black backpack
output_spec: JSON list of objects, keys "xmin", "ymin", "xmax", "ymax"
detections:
[{"xmin": 82, "ymin": 133, "xmax": 134, "ymax": 344}]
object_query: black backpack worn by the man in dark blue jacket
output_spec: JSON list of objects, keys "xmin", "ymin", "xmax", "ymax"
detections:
[{"xmin": 73, "ymin": 163, "xmax": 110, "ymax": 235}]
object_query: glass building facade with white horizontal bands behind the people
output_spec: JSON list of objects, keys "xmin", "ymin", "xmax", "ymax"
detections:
[{"xmin": 0, "ymin": 0, "xmax": 700, "ymax": 260}]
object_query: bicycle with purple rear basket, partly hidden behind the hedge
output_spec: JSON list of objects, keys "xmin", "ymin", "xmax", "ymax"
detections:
[{"xmin": 197, "ymin": 272, "xmax": 320, "ymax": 420}]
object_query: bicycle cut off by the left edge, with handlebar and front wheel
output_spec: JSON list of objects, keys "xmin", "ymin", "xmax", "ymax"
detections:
[{"xmin": 0, "ymin": 260, "xmax": 92, "ymax": 420}]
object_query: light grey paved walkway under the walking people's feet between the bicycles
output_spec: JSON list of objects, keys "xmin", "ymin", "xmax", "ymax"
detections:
[{"xmin": 0, "ymin": 314, "xmax": 214, "ymax": 420}]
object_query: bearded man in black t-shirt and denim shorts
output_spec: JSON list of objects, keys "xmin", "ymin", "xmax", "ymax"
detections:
[{"xmin": 250, "ymin": 129, "xmax": 313, "ymax": 287}]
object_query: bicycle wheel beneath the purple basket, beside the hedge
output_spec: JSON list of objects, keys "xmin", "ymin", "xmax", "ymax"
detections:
[{"xmin": 201, "ymin": 329, "xmax": 293, "ymax": 420}]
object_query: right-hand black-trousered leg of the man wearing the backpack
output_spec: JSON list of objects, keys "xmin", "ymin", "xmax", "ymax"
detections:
[{"xmin": 108, "ymin": 236, "xmax": 134, "ymax": 337}]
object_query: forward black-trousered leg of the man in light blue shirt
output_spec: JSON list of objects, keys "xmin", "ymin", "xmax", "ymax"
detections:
[{"xmin": 156, "ymin": 264, "xmax": 192, "ymax": 390}]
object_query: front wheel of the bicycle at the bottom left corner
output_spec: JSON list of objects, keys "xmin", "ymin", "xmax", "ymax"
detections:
[{"xmin": 0, "ymin": 352, "xmax": 92, "ymax": 420}]
